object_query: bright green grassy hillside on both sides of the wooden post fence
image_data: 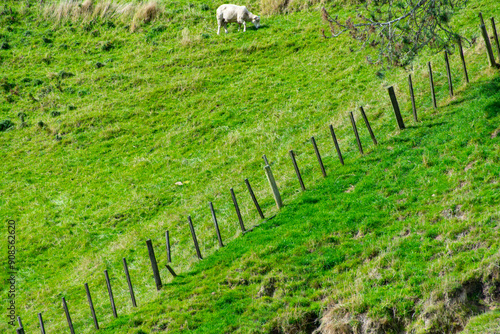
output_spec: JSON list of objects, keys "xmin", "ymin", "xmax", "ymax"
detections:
[{"xmin": 0, "ymin": 1, "xmax": 500, "ymax": 333}]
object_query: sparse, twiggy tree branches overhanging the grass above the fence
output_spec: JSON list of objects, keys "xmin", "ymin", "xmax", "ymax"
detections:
[{"xmin": 322, "ymin": 0, "xmax": 470, "ymax": 66}]
